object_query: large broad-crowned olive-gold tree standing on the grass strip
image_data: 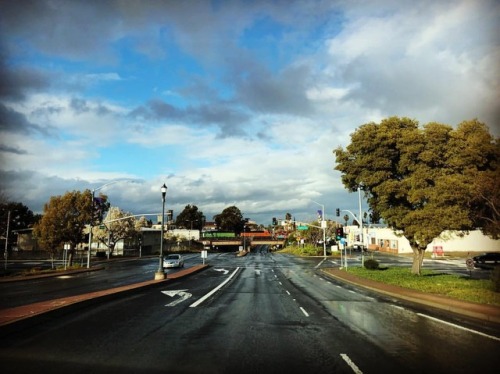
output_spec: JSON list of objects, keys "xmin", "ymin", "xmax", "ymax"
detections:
[{"xmin": 334, "ymin": 117, "xmax": 500, "ymax": 274}]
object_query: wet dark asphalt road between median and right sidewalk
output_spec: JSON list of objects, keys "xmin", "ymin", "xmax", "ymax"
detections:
[{"xmin": 0, "ymin": 253, "xmax": 500, "ymax": 373}]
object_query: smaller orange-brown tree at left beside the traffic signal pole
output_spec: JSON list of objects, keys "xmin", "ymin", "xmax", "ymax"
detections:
[{"xmin": 33, "ymin": 190, "xmax": 107, "ymax": 266}]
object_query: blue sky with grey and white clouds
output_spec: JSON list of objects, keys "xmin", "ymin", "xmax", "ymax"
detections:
[{"xmin": 0, "ymin": 0, "xmax": 500, "ymax": 226}]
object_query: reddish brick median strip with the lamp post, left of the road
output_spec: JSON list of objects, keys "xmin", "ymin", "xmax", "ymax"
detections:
[{"xmin": 0, "ymin": 265, "xmax": 208, "ymax": 327}]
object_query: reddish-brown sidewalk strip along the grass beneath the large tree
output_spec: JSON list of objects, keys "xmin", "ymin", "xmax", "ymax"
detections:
[{"xmin": 322, "ymin": 268, "xmax": 500, "ymax": 324}]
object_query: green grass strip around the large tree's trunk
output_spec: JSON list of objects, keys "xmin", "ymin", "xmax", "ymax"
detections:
[{"xmin": 347, "ymin": 267, "xmax": 500, "ymax": 306}]
